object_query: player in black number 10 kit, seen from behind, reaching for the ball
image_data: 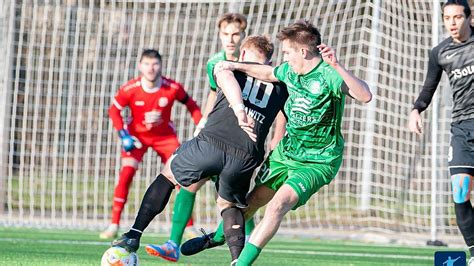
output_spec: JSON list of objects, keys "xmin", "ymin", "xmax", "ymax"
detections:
[{"xmin": 112, "ymin": 36, "xmax": 288, "ymax": 260}]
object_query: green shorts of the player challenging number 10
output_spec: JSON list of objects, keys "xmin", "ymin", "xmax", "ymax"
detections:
[{"xmin": 255, "ymin": 141, "xmax": 342, "ymax": 210}]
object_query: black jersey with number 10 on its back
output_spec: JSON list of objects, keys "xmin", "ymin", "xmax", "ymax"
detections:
[{"xmin": 198, "ymin": 71, "xmax": 288, "ymax": 161}]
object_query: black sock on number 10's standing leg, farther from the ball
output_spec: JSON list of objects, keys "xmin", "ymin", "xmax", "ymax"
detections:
[{"xmin": 221, "ymin": 207, "xmax": 245, "ymax": 260}]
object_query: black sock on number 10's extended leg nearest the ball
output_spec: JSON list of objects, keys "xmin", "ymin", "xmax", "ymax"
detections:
[{"xmin": 126, "ymin": 174, "xmax": 174, "ymax": 239}]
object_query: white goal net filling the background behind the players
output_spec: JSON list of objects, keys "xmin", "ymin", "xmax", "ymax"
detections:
[{"xmin": 0, "ymin": 0, "xmax": 459, "ymax": 244}]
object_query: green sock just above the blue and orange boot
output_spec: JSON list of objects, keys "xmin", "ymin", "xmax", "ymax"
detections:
[{"xmin": 170, "ymin": 188, "xmax": 196, "ymax": 246}]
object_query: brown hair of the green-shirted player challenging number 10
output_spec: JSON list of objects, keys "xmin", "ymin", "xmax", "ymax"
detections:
[{"xmin": 277, "ymin": 20, "xmax": 321, "ymax": 53}]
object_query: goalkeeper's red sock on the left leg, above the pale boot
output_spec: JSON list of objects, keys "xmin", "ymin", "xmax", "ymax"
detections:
[{"xmin": 112, "ymin": 166, "xmax": 136, "ymax": 224}]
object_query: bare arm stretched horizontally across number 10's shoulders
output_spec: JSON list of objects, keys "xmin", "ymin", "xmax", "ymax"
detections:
[{"xmin": 214, "ymin": 61, "xmax": 278, "ymax": 82}]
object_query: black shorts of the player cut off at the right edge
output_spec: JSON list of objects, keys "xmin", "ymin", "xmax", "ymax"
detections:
[{"xmin": 448, "ymin": 119, "xmax": 474, "ymax": 175}]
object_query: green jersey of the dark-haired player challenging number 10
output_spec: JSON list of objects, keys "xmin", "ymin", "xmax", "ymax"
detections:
[{"xmin": 274, "ymin": 60, "xmax": 345, "ymax": 163}]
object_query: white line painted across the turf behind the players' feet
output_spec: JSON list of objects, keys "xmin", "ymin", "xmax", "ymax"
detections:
[{"xmin": 0, "ymin": 238, "xmax": 434, "ymax": 261}]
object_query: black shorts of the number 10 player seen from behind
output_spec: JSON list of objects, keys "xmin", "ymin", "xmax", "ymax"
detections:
[{"xmin": 171, "ymin": 138, "xmax": 258, "ymax": 207}]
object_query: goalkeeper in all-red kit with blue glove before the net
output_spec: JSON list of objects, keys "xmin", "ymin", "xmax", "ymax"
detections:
[{"xmin": 100, "ymin": 49, "xmax": 201, "ymax": 239}]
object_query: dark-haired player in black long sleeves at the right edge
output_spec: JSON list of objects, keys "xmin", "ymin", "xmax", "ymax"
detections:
[{"xmin": 408, "ymin": 0, "xmax": 474, "ymax": 265}]
